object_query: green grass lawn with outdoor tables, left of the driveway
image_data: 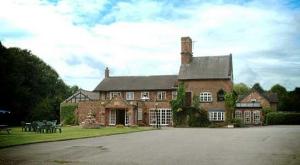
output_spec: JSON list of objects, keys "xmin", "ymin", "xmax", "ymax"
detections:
[{"xmin": 0, "ymin": 126, "xmax": 153, "ymax": 148}]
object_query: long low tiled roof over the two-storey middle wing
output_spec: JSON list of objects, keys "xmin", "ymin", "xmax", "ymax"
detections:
[{"xmin": 94, "ymin": 75, "xmax": 177, "ymax": 91}]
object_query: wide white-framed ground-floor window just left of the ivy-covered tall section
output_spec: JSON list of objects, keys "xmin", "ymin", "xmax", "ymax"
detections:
[{"xmin": 149, "ymin": 109, "xmax": 172, "ymax": 125}]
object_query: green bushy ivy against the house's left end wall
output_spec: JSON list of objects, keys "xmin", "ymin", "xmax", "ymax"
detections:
[{"xmin": 60, "ymin": 104, "xmax": 77, "ymax": 125}]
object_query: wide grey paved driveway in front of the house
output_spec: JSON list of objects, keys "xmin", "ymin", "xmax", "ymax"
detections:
[{"xmin": 0, "ymin": 126, "xmax": 300, "ymax": 165}]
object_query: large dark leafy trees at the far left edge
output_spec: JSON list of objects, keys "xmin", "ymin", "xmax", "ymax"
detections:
[{"xmin": 0, "ymin": 43, "xmax": 71, "ymax": 124}]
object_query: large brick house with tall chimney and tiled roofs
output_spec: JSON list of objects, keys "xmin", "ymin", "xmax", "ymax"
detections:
[{"xmin": 63, "ymin": 37, "xmax": 233, "ymax": 126}]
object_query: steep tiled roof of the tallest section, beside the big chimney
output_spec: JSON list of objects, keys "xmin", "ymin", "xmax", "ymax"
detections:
[{"xmin": 178, "ymin": 55, "xmax": 232, "ymax": 80}]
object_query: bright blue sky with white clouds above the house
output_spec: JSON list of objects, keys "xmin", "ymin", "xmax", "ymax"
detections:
[{"xmin": 0, "ymin": 0, "xmax": 300, "ymax": 90}]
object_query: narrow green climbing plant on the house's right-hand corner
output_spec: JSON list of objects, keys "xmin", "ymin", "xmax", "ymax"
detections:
[{"xmin": 225, "ymin": 92, "xmax": 237, "ymax": 122}]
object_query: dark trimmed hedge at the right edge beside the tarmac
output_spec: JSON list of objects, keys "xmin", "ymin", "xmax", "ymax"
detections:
[{"xmin": 266, "ymin": 112, "xmax": 300, "ymax": 125}]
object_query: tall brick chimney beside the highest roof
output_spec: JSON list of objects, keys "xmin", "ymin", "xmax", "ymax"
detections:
[{"xmin": 181, "ymin": 37, "xmax": 193, "ymax": 64}]
